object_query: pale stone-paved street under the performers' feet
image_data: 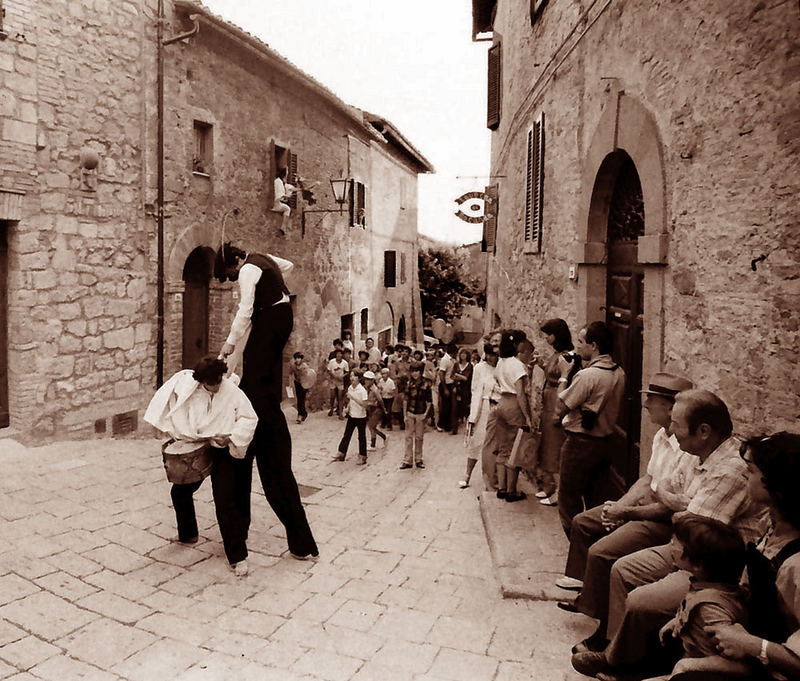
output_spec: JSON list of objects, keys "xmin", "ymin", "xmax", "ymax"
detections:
[{"xmin": 0, "ymin": 408, "xmax": 591, "ymax": 681}]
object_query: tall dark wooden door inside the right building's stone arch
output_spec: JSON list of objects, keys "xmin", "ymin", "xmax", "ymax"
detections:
[{"xmin": 595, "ymin": 150, "xmax": 645, "ymax": 486}]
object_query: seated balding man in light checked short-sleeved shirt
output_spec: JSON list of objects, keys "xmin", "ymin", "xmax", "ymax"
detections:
[{"xmin": 573, "ymin": 390, "xmax": 766, "ymax": 673}]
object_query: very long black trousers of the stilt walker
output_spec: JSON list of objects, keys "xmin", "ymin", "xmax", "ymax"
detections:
[{"xmin": 236, "ymin": 303, "xmax": 319, "ymax": 556}]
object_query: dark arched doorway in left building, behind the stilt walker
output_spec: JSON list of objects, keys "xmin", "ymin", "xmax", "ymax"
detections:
[{"xmin": 181, "ymin": 246, "xmax": 214, "ymax": 369}]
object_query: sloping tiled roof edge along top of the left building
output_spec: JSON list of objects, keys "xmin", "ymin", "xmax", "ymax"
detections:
[{"xmin": 174, "ymin": 0, "xmax": 434, "ymax": 173}]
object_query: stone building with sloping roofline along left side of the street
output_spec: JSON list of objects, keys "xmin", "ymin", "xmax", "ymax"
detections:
[{"xmin": 0, "ymin": 0, "xmax": 432, "ymax": 440}]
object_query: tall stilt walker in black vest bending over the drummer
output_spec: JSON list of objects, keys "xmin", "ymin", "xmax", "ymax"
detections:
[{"xmin": 214, "ymin": 242, "xmax": 319, "ymax": 560}]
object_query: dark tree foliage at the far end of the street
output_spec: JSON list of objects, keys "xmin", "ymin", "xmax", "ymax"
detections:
[{"xmin": 419, "ymin": 248, "xmax": 486, "ymax": 321}]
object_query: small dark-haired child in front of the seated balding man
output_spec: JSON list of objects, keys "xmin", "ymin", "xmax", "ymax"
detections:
[{"xmin": 659, "ymin": 515, "xmax": 748, "ymax": 675}]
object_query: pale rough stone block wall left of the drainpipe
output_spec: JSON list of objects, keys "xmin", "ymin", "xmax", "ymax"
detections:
[{"xmin": 0, "ymin": 0, "xmax": 155, "ymax": 439}]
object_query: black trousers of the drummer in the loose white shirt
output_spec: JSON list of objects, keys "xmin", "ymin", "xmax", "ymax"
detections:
[{"xmin": 170, "ymin": 447, "xmax": 247, "ymax": 565}]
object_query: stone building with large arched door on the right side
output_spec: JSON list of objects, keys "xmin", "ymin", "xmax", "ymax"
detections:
[{"xmin": 473, "ymin": 0, "xmax": 800, "ymax": 480}]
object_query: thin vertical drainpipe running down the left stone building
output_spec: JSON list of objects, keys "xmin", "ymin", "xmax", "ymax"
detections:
[{"xmin": 156, "ymin": 0, "xmax": 164, "ymax": 388}]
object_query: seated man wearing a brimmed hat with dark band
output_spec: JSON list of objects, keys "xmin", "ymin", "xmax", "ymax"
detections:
[{"xmin": 556, "ymin": 373, "xmax": 698, "ymax": 650}]
